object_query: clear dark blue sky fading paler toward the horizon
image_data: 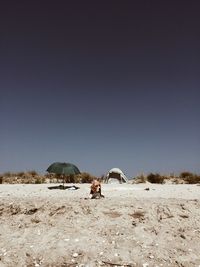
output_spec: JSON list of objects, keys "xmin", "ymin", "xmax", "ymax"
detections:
[{"xmin": 0, "ymin": 1, "xmax": 200, "ymax": 177}]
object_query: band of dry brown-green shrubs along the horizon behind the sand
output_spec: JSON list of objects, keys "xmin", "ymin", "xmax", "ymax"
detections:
[{"xmin": 0, "ymin": 170, "xmax": 200, "ymax": 184}]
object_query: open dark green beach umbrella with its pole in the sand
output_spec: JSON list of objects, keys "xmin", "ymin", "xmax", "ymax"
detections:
[{"xmin": 47, "ymin": 162, "xmax": 81, "ymax": 187}]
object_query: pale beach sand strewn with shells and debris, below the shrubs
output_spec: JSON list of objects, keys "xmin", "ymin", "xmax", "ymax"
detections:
[{"xmin": 0, "ymin": 184, "xmax": 200, "ymax": 267}]
